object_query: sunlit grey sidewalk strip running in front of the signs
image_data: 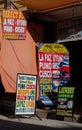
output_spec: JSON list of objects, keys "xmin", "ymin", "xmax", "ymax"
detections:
[{"xmin": 0, "ymin": 115, "xmax": 82, "ymax": 128}]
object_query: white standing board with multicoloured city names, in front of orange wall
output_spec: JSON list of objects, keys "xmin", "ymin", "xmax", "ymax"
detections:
[{"xmin": 15, "ymin": 74, "xmax": 36, "ymax": 115}]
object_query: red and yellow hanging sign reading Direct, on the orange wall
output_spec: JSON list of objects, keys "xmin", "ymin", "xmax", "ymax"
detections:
[{"xmin": 2, "ymin": 10, "xmax": 27, "ymax": 39}]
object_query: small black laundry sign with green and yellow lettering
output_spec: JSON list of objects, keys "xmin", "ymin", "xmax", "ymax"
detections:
[{"xmin": 57, "ymin": 87, "xmax": 75, "ymax": 116}]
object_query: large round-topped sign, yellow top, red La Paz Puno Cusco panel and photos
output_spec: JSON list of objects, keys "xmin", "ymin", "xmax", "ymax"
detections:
[{"xmin": 38, "ymin": 43, "xmax": 70, "ymax": 105}]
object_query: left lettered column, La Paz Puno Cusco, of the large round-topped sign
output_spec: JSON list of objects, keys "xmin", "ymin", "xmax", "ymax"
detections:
[{"xmin": 39, "ymin": 52, "xmax": 53, "ymax": 105}]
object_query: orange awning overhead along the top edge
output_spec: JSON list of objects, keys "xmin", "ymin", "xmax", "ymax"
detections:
[{"xmin": 15, "ymin": 0, "xmax": 82, "ymax": 12}]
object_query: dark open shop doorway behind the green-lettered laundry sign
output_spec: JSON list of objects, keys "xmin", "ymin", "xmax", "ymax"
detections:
[{"xmin": 63, "ymin": 40, "xmax": 82, "ymax": 107}]
